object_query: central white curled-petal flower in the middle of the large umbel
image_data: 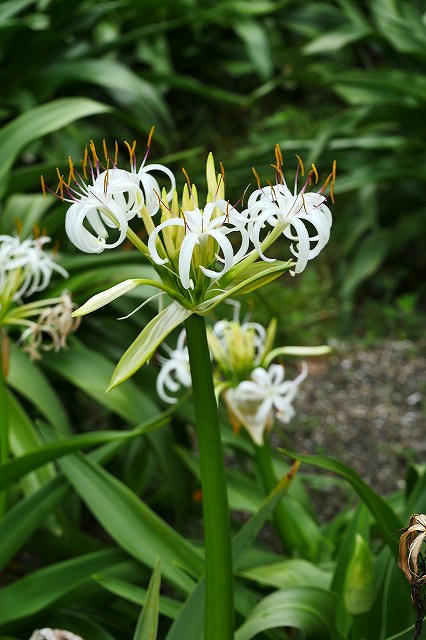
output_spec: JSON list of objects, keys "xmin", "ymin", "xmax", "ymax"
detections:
[{"xmin": 148, "ymin": 200, "xmax": 249, "ymax": 289}]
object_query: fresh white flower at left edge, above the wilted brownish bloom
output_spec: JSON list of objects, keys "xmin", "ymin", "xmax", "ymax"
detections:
[{"xmin": 0, "ymin": 235, "xmax": 68, "ymax": 309}]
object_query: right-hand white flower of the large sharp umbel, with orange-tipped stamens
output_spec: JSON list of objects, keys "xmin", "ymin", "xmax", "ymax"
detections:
[{"xmin": 246, "ymin": 146, "xmax": 336, "ymax": 275}]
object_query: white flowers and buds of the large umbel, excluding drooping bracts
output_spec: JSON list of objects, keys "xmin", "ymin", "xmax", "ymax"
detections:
[{"xmin": 50, "ymin": 137, "xmax": 335, "ymax": 291}]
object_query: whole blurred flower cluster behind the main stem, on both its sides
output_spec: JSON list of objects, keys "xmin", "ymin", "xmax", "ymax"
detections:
[{"xmin": 157, "ymin": 306, "xmax": 329, "ymax": 446}]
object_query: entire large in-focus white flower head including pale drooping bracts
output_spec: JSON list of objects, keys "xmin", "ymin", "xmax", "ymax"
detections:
[{"xmin": 50, "ymin": 130, "xmax": 336, "ymax": 388}]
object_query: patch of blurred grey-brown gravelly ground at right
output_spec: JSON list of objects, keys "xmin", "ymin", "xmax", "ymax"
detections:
[{"xmin": 287, "ymin": 341, "xmax": 426, "ymax": 518}]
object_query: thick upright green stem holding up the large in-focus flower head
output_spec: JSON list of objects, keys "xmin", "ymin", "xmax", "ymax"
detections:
[{"xmin": 185, "ymin": 314, "xmax": 234, "ymax": 640}]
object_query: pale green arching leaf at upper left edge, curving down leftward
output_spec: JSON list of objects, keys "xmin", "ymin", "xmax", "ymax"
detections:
[{"xmin": 0, "ymin": 98, "xmax": 110, "ymax": 197}]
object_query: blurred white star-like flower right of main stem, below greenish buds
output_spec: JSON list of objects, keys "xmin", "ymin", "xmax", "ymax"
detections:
[{"xmin": 225, "ymin": 363, "xmax": 307, "ymax": 446}]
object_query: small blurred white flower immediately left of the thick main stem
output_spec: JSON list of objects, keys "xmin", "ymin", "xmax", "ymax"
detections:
[{"xmin": 156, "ymin": 330, "xmax": 192, "ymax": 404}]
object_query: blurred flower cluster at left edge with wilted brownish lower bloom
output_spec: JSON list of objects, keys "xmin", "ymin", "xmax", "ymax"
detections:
[{"xmin": 0, "ymin": 235, "xmax": 79, "ymax": 359}]
